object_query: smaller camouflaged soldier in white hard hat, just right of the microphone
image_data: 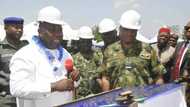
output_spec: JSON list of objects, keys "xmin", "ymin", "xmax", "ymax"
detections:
[{"xmin": 73, "ymin": 26, "xmax": 103, "ymax": 98}]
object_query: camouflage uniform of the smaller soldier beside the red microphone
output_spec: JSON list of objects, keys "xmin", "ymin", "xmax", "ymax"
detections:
[{"xmin": 73, "ymin": 51, "xmax": 103, "ymax": 98}]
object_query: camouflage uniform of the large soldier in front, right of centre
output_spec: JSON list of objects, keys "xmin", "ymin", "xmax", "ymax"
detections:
[{"xmin": 103, "ymin": 41, "xmax": 166, "ymax": 88}]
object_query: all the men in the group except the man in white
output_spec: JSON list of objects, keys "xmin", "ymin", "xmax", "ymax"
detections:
[{"xmin": 0, "ymin": 7, "xmax": 190, "ymax": 107}]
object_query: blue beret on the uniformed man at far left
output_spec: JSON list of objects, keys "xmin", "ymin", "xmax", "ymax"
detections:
[{"xmin": 4, "ymin": 17, "xmax": 24, "ymax": 24}]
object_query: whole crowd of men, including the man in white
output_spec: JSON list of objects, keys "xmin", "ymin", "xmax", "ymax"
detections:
[{"xmin": 0, "ymin": 6, "xmax": 190, "ymax": 107}]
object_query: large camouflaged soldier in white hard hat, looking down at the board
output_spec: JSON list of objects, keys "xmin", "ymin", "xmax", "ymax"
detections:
[{"xmin": 100, "ymin": 10, "xmax": 166, "ymax": 89}]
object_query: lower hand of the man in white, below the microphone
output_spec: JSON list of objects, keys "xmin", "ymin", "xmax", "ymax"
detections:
[{"xmin": 51, "ymin": 79, "xmax": 74, "ymax": 92}]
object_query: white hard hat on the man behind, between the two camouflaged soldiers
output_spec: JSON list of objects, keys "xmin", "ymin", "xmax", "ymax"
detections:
[{"xmin": 98, "ymin": 18, "xmax": 116, "ymax": 33}]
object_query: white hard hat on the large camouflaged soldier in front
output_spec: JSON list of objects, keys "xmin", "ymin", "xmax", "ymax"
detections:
[{"xmin": 119, "ymin": 10, "xmax": 141, "ymax": 30}]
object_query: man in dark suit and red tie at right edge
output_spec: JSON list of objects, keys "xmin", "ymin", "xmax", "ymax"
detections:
[{"xmin": 171, "ymin": 22, "xmax": 190, "ymax": 107}]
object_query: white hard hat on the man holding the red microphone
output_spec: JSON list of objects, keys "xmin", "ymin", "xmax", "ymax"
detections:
[{"xmin": 37, "ymin": 6, "xmax": 64, "ymax": 25}]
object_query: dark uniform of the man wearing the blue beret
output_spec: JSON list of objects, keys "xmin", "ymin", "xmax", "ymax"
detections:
[{"xmin": 0, "ymin": 39, "xmax": 27, "ymax": 107}]
